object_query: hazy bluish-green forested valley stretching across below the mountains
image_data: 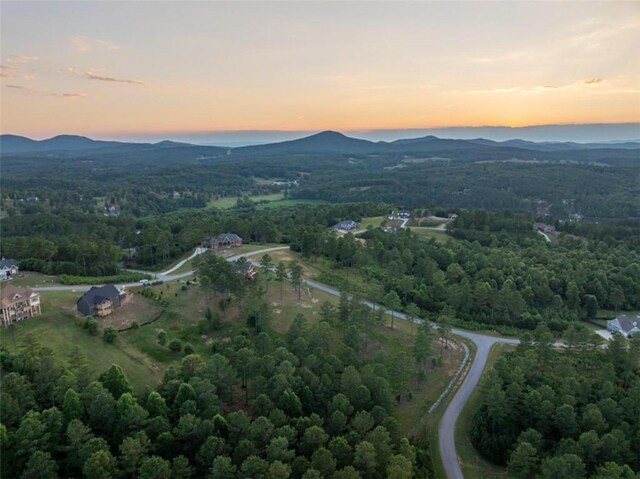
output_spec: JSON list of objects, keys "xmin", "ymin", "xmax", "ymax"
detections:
[{"xmin": 0, "ymin": 138, "xmax": 640, "ymax": 218}]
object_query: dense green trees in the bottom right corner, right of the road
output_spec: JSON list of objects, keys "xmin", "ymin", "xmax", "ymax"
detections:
[{"xmin": 471, "ymin": 328, "xmax": 640, "ymax": 479}]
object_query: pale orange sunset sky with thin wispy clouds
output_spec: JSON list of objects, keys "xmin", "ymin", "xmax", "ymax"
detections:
[{"xmin": 0, "ymin": 0, "xmax": 640, "ymax": 139}]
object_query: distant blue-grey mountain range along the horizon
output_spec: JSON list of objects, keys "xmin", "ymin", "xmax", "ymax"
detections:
[{"xmin": 0, "ymin": 131, "xmax": 640, "ymax": 157}]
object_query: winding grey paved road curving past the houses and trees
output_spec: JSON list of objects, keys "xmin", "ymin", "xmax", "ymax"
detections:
[{"xmin": 33, "ymin": 246, "xmax": 520, "ymax": 479}]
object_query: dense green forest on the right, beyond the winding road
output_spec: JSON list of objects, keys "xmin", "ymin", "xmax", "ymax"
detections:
[{"xmin": 292, "ymin": 211, "xmax": 640, "ymax": 331}]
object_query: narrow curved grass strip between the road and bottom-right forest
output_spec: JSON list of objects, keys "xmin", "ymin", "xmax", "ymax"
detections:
[{"xmin": 455, "ymin": 344, "xmax": 512, "ymax": 479}]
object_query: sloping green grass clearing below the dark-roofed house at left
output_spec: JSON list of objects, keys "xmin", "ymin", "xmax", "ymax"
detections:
[{"xmin": 0, "ymin": 304, "xmax": 163, "ymax": 391}]
